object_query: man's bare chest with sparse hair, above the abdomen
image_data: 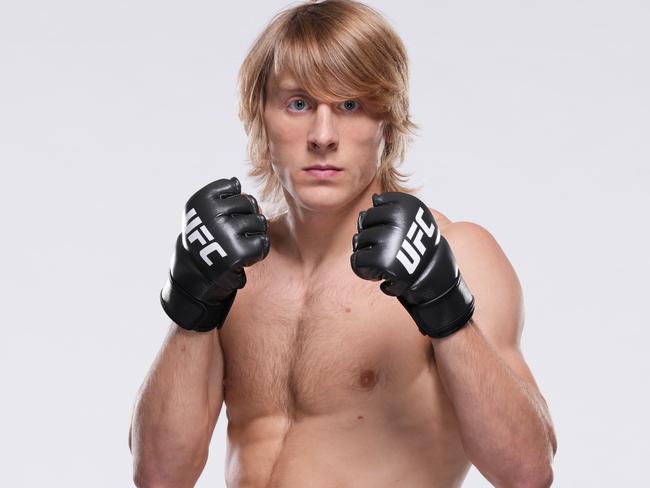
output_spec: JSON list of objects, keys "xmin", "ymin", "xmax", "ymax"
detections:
[{"xmin": 220, "ymin": 260, "xmax": 436, "ymax": 422}]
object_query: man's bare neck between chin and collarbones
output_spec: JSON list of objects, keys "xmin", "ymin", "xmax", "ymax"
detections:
[{"xmin": 280, "ymin": 178, "xmax": 381, "ymax": 276}]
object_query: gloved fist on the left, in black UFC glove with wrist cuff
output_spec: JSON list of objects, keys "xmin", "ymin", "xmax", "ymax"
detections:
[{"xmin": 160, "ymin": 178, "xmax": 270, "ymax": 332}]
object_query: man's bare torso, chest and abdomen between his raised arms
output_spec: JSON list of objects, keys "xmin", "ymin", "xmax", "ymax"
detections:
[{"xmin": 219, "ymin": 213, "xmax": 470, "ymax": 488}]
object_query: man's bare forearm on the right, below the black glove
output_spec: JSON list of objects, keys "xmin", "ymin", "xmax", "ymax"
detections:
[{"xmin": 431, "ymin": 322, "xmax": 553, "ymax": 486}]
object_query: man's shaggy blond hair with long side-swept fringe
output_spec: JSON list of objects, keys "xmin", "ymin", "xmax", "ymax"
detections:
[{"xmin": 238, "ymin": 0, "xmax": 418, "ymax": 217}]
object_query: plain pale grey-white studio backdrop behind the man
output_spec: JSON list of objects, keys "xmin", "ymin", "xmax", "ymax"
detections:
[{"xmin": 0, "ymin": 0, "xmax": 650, "ymax": 487}]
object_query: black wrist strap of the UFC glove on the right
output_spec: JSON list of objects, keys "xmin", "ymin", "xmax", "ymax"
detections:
[{"xmin": 397, "ymin": 273, "xmax": 474, "ymax": 339}]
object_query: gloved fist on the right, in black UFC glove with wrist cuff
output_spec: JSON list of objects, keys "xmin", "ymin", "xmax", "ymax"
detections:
[{"xmin": 350, "ymin": 192, "xmax": 474, "ymax": 338}]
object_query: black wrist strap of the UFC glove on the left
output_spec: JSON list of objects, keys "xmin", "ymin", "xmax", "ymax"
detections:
[{"xmin": 160, "ymin": 273, "xmax": 237, "ymax": 332}]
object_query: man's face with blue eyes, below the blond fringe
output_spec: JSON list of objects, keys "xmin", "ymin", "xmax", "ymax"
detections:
[{"xmin": 264, "ymin": 70, "xmax": 384, "ymax": 211}]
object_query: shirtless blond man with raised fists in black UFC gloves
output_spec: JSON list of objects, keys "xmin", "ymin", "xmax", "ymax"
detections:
[{"xmin": 129, "ymin": 1, "xmax": 557, "ymax": 488}]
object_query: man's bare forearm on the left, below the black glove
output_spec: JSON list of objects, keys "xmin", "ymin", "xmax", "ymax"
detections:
[{"xmin": 130, "ymin": 325, "xmax": 222, "ymax": 487}]
